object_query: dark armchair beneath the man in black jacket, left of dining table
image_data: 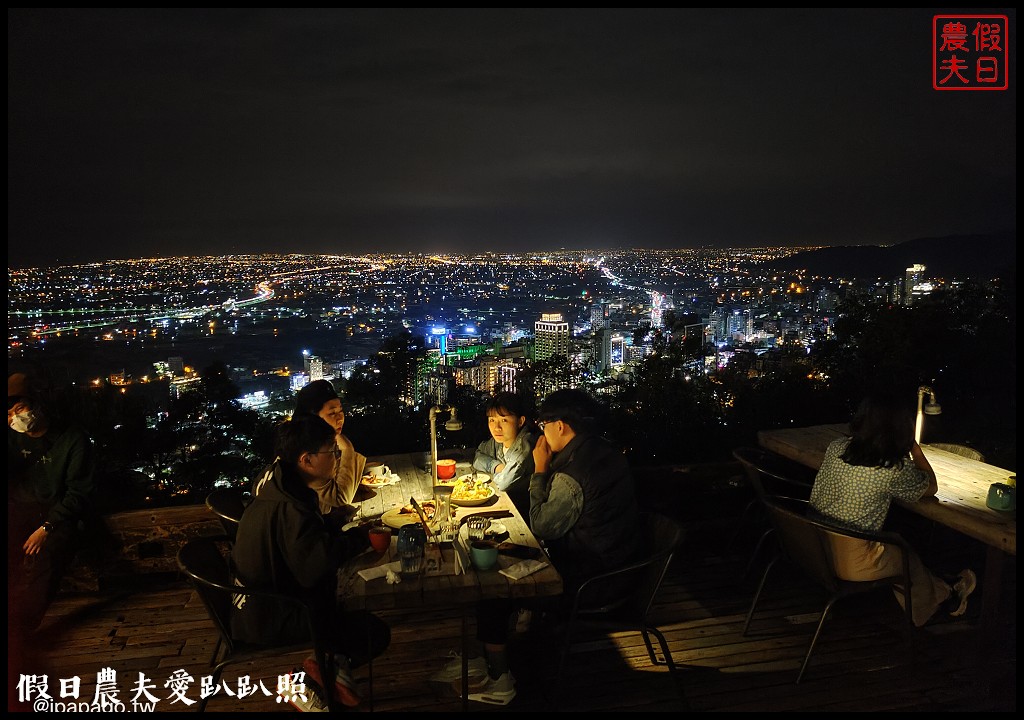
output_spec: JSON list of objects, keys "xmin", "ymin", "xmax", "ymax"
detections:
[{"xmin": 177, "ymin": 537, "xmax": 341, "ymax": 712}]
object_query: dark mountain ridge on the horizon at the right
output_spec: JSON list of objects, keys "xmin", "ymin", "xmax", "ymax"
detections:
[{"xmin": 765, "ymin": 231, "xmax": 1017, "ymax": 280}]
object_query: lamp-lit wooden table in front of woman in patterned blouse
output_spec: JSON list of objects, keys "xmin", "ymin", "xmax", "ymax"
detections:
[{"xmin": 758, "ymin": 423, "xmax": 1017, "ymax": 639}]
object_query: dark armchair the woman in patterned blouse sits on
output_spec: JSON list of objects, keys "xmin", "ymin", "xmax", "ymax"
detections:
[{"xmin": 742, "ymin": 497, "xmax": 913, "ymax": 683}]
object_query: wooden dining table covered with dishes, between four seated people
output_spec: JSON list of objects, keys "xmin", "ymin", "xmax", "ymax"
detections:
[{"xmin": 338, "ymin": 453, "xmax": 562, "ymax": 710}]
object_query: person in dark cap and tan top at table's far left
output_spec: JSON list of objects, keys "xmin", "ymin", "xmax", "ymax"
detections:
[{"xmin": 254, "ymin": 380, "xmax": 367, "ymax": 524}]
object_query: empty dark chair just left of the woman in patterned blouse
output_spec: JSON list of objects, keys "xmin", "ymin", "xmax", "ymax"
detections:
[{"xmin": 732, "ymin": 447, "xmax": 814, "ymax": 578}]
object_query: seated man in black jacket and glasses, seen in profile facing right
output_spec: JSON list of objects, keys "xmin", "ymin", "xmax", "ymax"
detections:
[{"xmin": 231, "ymin": 415, "xmax": 391, "ymax": 706}]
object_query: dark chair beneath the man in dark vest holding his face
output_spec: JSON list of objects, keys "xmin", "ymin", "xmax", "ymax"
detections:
[{"xmin": 555, "ymin": 512, "xmax": 683, "ymax": 704}]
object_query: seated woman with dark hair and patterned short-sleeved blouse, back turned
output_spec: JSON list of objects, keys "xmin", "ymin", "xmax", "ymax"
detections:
[{"xmin": 810, "ymin": 392, "xmax": 977, "ymax": 627}]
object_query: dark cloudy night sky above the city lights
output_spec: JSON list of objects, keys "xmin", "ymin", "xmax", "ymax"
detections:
[{"xmin": 7, "ymin": 8, "xmax": 1017, "ymax": 267}]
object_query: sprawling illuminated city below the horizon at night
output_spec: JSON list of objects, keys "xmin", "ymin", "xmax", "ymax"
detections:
[{"xmin": 7, "ymin": 248, "xmax": 1011, "ymax": 510}]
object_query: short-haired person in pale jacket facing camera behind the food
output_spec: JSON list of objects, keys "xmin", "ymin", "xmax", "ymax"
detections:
[{"xmin": 473, "ymin": 392, "xmax": 538, "ymax": 517}]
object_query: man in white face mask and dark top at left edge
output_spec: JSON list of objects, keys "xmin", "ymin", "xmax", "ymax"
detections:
[{"xmin": 7, "ymin": 373, "xmax": 94, "ymax": 633}]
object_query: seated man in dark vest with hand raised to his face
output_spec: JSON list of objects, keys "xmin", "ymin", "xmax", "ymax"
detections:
[{"xmin": 431, "ymin": 390, "xmax": 642, "ymax": 705}]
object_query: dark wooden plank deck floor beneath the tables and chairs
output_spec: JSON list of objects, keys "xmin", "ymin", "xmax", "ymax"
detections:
[{"xmin": 8, "ymin": 516, "xmax": 1017, "ymax": 712}]
